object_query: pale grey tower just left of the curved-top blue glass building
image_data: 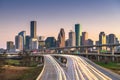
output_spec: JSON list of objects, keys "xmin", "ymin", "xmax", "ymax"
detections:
[{"xmin": 15, "ymin": 35, "xmax": 23, "ymax": 50}]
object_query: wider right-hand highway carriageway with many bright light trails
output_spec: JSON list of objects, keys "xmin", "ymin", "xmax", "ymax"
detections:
[{"xmin": 64, "ymin": 55, "xmax": 112, "ymax": 80}]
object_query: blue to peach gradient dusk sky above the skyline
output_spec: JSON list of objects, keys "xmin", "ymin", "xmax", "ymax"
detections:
[{"xmin": 0, "ymin": 0, "xmax": 120, "ymax": 48}]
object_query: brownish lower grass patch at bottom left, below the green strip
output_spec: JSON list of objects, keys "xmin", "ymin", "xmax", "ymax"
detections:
[{"xmin": 0, "ymin": 65, "xmax": 43, "ymax": 80}]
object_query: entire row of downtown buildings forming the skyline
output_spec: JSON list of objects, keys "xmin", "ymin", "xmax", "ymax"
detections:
[{"xmin": 7, "ymin": 21, "xmax": 119, "ymax": 52}]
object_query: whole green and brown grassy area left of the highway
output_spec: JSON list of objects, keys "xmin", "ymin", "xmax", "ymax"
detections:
[{"xmin": 0, "ymin": 59, "xmax": 43, "ymax": 80}]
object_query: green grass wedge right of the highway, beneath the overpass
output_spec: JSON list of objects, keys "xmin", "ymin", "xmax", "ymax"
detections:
[{"xmin": 95, "ymin": 62, "xmax": 120, "ymax": 75}]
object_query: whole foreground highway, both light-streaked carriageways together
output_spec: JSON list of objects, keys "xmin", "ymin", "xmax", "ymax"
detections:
[{"xmin": 37, "ymin": 54, "xmax": 120, "ymax": 80}]
